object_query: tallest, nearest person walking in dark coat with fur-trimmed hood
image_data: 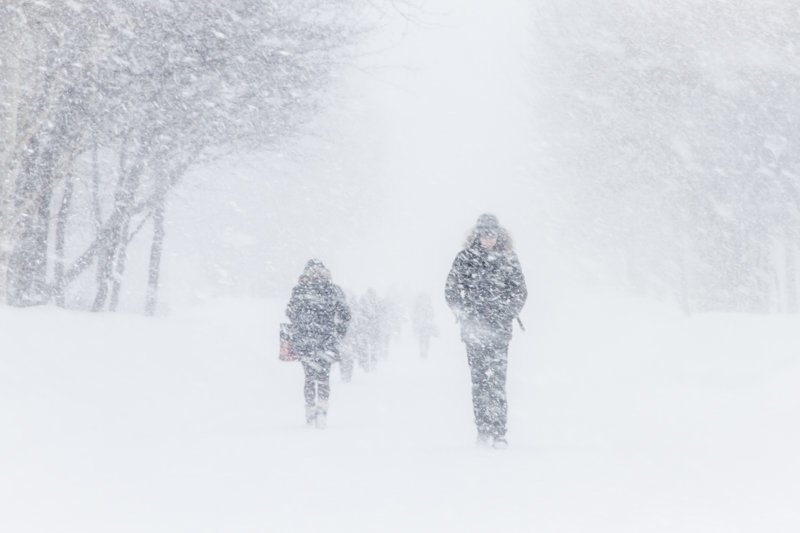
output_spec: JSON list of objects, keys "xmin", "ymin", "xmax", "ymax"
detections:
[{"xmin": 445, "ymin": 214, "xmax": 528, "ymax": 448}]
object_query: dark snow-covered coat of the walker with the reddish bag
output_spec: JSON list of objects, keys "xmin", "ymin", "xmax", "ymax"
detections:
[{"xmin": 286, "ymin": 275, "xmax": 350, "ymax": 358}]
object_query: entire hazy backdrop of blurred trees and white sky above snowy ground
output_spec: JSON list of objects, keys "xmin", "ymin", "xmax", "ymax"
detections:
[{"xmin": 0, "ymin": 0, "xmax": 800, "ymax": 313}]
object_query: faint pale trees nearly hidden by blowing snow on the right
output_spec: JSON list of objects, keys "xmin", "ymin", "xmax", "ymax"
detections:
[{"xmin": 531, "ymin": 0, "xmax": 800, "ymax": 312}]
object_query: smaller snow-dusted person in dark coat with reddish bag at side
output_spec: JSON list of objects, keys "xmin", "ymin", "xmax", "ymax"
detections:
[{"xmin": 286, "ymin": 259, "xmax": 350, "ymax": 428}]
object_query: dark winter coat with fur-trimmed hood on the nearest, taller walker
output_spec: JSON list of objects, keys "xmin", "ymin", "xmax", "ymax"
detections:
[{"xmin": 445, "ymin": 239, "xmax": 528, "ymax": 342}]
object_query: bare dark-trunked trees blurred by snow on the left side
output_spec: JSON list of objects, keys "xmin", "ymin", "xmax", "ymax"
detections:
[{"xmin": 0, "ymin": 0, "xmax": 365, "ymax": 313}]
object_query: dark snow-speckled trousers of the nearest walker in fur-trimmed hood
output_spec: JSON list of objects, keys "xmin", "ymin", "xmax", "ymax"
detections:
[{"xmin": 466, "ymin": 339, "xmax": 508, "ymax": 438}]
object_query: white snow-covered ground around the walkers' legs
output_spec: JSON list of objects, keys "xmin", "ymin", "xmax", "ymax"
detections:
[{"xmin": 0, "ymin": 295, "xmax": 800, "ymax": 533}]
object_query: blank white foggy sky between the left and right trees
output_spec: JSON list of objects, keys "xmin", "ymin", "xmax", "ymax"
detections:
[{"xmin": 163, "ymin": 1, "xmax": 540, "ymax": 308}]
